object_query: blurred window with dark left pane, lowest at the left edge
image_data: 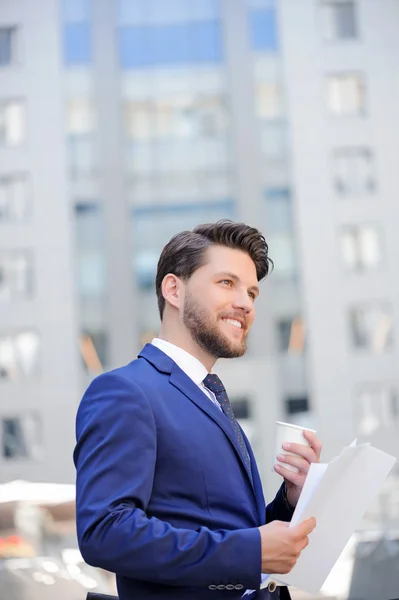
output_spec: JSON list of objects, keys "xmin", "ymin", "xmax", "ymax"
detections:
[{"xmin": 1, "ymin": 413, "xmax": 43, "ymax": 460}]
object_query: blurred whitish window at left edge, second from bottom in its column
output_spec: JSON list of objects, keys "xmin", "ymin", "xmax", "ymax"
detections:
[{"xmin": 0, "ymin": 331, "xmax": 40, "ymax": 381}]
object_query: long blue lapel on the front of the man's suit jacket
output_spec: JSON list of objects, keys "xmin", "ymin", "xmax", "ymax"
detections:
[{"xmin": 169, "ymin": 363, "xmax": 255, "ymax": 493}]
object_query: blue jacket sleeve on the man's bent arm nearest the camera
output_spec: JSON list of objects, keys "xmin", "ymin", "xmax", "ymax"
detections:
[{"xmin": 74, "ymin": 373, "xmax": 261, "ymax": 589}]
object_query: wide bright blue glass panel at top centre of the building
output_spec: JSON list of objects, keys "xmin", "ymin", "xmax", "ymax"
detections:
[{"xmin": 118, "ymin": 20, "xmax": 223, "ymax": 69}]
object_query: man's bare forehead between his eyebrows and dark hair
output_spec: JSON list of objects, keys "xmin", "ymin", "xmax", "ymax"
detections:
[{"xmin": 198, "ymin": 246, "xmax": 258, "ymax": 285}]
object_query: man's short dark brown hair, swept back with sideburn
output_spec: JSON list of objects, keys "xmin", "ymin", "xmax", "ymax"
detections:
[{"xmin": 155, "ymin": 219, "xmax": 273, "ymax": 320}]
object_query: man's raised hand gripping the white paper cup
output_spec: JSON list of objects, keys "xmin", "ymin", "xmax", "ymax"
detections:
[{"xmin": 274, "ymin": 431, "xmax": 322, "ymax": 506}]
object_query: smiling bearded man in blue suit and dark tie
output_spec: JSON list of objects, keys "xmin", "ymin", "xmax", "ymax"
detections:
[{"xmin": 74, "ymin": 221, "xmax": 321, "ymax": 600}]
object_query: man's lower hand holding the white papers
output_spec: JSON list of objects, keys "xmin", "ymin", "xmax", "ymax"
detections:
[{"xmin": 259, "ymin": 518, "xmax": 316, "ymax": 574}]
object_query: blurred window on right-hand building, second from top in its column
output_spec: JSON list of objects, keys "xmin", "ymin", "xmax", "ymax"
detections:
[{"xmin": 327, "ymin": 73, "xmax": 366, "ymax": 116}]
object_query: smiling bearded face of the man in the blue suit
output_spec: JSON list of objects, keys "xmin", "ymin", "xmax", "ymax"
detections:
[{"xmin": 183, "ymin": 246, "xmax": 259, "ymax": 359}]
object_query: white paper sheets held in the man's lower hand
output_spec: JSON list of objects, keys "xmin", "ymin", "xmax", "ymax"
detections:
[{"xmin": 261, "ymin": 442, "xmax": 396, "ymax": 594}]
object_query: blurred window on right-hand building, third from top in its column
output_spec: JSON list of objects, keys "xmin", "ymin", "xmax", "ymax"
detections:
[{"xmin": 334, "ymin": 148, "xmax": 377, "ymax": 196}]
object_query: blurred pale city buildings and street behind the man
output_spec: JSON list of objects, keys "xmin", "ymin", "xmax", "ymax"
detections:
[{"xmin": 0, "ymin": 0, "xmax": 399, "ymax": 600}]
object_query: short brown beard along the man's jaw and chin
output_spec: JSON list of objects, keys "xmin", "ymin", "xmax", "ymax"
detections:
[{"xmin": 183, "ymin": 294, "xmax": 247, "ymax": 359}]
